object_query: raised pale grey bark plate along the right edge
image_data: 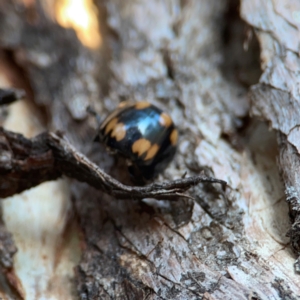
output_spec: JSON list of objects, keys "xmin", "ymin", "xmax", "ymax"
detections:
[{"xmin": 241, "ymin": 0, "xmax": 300, "ymax": 272}]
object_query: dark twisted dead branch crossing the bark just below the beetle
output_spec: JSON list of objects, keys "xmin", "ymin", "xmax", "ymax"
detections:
[{"xmin": 0, "ymin": 127, "xmax": 226, "ymax": 200}]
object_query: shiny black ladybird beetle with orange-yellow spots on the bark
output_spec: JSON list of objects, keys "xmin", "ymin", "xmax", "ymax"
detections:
[{"xmin": 95, "ymin": 101, "xmax": 178, "ymax": 184}]
